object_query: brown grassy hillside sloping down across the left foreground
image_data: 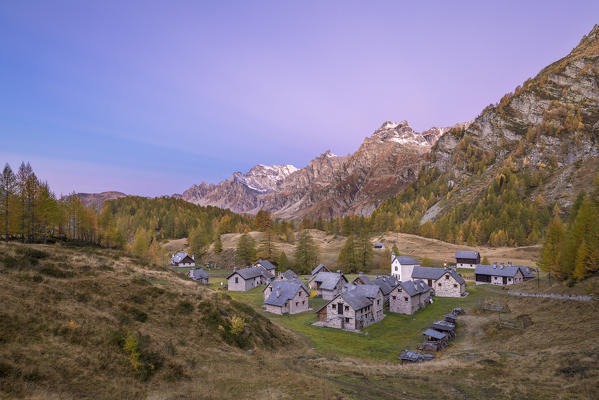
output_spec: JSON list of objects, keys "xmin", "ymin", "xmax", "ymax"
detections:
[{"xmin": 0, "ymin": 243, "xmax": 338, "ymax": 399}]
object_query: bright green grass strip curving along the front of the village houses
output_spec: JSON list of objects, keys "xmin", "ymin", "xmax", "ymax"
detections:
[{"xmin": 228, "ymin": 285, "xmax": 487, "ymax": 361}]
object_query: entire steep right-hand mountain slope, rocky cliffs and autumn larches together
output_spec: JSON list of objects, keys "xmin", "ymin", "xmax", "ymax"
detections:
[{"xmin": 378, "ymin": 25, "xmax": 599, "ymax": 245}]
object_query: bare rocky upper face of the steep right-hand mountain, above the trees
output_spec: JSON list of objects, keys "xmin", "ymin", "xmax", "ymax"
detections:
[{"xmin": 422, "ymin": 25, "xmax": 599, "ymax": 222}]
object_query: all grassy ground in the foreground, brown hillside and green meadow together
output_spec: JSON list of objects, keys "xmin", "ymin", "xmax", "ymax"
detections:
[{"xmin": 0, "ymin": 243, "xmax": 599, "ymax": 399}]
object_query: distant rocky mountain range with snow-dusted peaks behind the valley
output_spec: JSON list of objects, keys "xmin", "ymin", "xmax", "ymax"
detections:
[{"xmin": 183, "ymin": 121, "xmax": 460, "ymax": 219}]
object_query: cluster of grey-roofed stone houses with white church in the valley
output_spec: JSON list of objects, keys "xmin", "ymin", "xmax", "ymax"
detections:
[{"xmin": 171, "ymin": 242, "xmax": 538, "ymax": 363}]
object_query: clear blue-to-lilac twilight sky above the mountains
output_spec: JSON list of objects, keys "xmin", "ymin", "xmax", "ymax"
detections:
[{"xmin": 0, "ymin": 0, "xmax": 599, "ymax": 196}]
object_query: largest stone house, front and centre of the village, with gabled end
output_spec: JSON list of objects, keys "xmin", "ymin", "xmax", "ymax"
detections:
[{"xmin": 314, "ymin": 285, "xmax": 385, "ymax": 331}]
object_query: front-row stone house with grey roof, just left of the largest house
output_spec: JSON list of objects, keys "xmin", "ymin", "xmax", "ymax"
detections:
[{"xmin": 264, "ymin": 279, "xmax": 310, "ymax": 315}]
